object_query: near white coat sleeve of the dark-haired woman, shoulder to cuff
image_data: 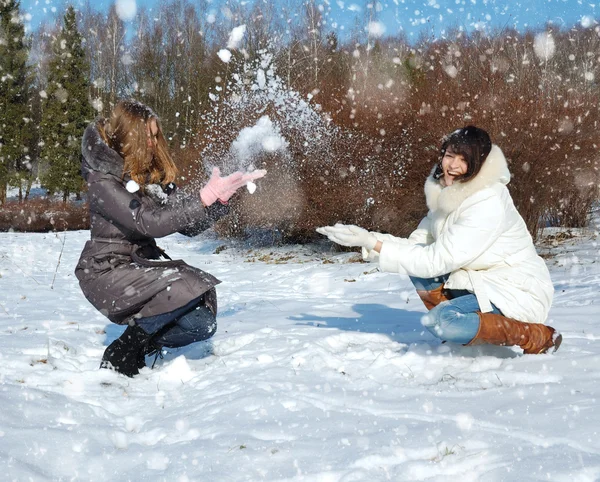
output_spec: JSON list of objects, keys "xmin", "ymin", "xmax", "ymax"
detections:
[{"xmin": 379, "ymin": 190, "xmax": 505, "ymax": 278}]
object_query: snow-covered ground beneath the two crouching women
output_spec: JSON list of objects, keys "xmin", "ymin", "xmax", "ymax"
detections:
[{"xmin": 0, "ymin": 217, "xmax": 600, "ymax": 482}]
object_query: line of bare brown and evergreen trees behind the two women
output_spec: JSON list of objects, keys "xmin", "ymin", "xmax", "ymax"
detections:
[{"xmin": 0, "ymin": 0, "xmax": 600, "ymax": 239}]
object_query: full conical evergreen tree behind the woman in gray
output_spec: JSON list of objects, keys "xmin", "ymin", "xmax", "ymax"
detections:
[{"xmin": 41, "ymin": 6, "xmax": 94, "ymax": 202}]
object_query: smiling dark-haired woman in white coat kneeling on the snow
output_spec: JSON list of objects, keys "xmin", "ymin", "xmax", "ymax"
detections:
[{"xmin": 317, "ymin": 126, "xmax": 562, "ymax": 353}]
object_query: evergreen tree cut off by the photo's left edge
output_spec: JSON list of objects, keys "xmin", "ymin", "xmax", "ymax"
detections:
[{"xmin": 0, "ymin": 0, "xmax": 35, "ymax": 204}]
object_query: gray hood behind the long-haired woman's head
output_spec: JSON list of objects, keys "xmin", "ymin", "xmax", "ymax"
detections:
[{"xmin": 81, "ymin": 119, "xmax": 123, "ymax": 180}]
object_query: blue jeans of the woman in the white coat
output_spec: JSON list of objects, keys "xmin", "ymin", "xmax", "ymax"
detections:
[{"xmin": 410, "ymin": 275, "xmax": 502, "ymax": 345}]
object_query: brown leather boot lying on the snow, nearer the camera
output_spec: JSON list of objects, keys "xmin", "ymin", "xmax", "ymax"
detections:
[{"xmin": 467, "ymin": 312, "xmax": 562, "ymax": 354}]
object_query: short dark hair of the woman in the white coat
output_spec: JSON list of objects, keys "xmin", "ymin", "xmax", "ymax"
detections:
[{"xmin": 433, "ymin": 126, "xmax": 492, "ymax": 182}]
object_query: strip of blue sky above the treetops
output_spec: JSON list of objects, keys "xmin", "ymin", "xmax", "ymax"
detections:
[{"xmin": 21, "ymin": 0, "xmax": 600, "ymax": 38}]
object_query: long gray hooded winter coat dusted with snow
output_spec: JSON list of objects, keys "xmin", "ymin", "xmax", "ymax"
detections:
[{"xmin": 75, "ymin": 122, "xmax": 223, "ymax": 324}]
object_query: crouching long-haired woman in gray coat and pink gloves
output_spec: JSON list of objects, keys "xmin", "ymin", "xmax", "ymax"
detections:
[{"xmin": 75, "ymin": 100, "xmax": 266, "ymax": 376}]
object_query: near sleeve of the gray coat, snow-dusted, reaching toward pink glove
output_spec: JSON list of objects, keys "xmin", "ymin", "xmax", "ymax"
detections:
[{"xmin": 88, "ymin": 177, "xmax": 208, "ymax": 238}]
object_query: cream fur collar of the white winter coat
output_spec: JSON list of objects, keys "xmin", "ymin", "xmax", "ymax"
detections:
[{"xmin": 425, "ymin": 145, "xmax": 510, "ymax": 214}]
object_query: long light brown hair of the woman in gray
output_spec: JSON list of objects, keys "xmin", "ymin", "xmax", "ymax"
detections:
[{"xmin": 98, "ymin": 100, "xmax": 177, "ymax": 186}]
